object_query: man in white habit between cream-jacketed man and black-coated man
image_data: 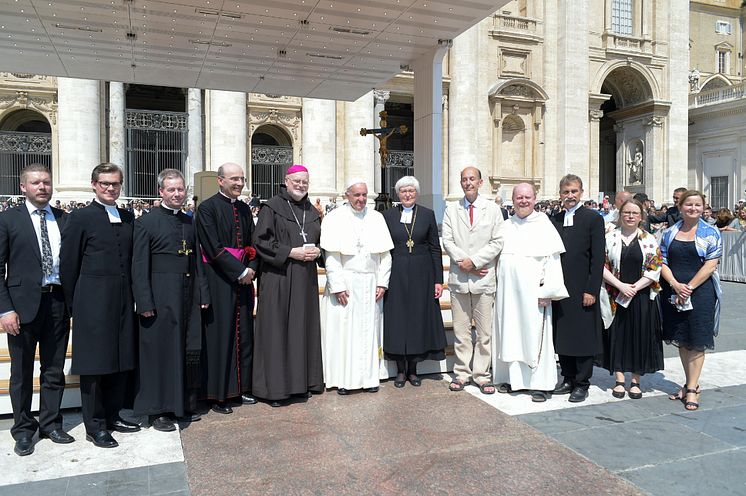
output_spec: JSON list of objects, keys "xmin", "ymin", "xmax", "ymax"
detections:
[{"xmin": 492, "ymin": 183, "xmax": 568, "ymax": 402}]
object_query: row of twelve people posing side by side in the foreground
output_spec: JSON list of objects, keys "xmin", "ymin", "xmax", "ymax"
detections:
[{"xmin": 0, "ymin": 163, "xmax": 722, "ymax": 456}]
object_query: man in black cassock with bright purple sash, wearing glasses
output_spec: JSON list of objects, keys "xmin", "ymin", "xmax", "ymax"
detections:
[{"xmin": 195, "ymin": 163, "xmax": 258, "ymax": 414}]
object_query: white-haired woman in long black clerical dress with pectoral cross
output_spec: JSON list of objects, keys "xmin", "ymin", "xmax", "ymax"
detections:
[{"xmin": 383, "ymin": 176, "xmax": 446, "ymax": 388}]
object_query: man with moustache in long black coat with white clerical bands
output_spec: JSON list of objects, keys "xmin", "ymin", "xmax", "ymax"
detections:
[{"xmin": 552, "ymin": 174, "xmax": 605, "ymax": 403}]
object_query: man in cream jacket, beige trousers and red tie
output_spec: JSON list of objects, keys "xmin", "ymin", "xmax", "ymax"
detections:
[{"xmin": 443, "ymin": 167, "xmax": 503, "ymax": 394}]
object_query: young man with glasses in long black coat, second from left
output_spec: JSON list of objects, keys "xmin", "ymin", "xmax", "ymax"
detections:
[{"xmin": 60, "ymin": 163, "xmax": 140, "ymax": 448}]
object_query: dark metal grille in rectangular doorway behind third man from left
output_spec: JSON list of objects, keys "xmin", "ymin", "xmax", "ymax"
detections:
[{"xmin": 125, "ymin": 110, "xmax": 188, "ymax": 198}]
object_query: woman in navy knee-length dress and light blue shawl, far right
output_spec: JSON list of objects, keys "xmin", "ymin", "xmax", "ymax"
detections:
[{"xmin": 661, "ymin": 191, "xmax": 723, "ymax": 410}]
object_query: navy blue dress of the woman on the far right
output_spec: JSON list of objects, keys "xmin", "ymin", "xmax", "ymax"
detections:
[{"xmin": 661, "ymin": 239, "xmax": 717, "ymax": 351}]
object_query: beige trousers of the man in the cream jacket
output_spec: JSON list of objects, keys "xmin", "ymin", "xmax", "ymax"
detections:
[{"xmin": 451, "ymin": 293, "xmax": 495, "ymax": 384}]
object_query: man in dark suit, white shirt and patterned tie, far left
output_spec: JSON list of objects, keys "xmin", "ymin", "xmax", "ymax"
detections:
[{"xmin": 0, "ymin": 164, "xmax": 75, "ymax": 456}]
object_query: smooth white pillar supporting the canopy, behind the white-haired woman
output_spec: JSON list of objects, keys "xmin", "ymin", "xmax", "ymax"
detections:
[{"xmin": 413, "ymin": 43, "xmax": 449, "ymax": 222}]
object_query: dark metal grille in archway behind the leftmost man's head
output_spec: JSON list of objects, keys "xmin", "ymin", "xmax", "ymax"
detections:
[{"xmin": 0, "ymin": 131, "xmax": 52, "ymax": 196}]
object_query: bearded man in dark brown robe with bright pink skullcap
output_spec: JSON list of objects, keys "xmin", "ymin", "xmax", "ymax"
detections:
[{"xmin": 253, "ymin": 165, "xmax": 324, "ymax": 406}]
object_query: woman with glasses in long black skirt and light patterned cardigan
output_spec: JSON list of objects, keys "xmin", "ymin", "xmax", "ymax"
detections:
[{"xmin": 600, "ymin": 200, "xmax": 663, "ymax": 399}]
